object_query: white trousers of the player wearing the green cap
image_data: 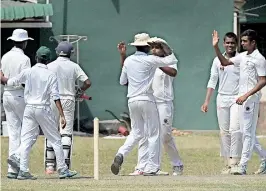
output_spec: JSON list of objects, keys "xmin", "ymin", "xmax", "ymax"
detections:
[{"xmin": 20, "ymin": 105, "xmax": 67, "ymax": 172}]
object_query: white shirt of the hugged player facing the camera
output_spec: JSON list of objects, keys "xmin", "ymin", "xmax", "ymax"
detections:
[{"xmin": 152, "ymin": 64, "xmax": 177, "ymax": 102}]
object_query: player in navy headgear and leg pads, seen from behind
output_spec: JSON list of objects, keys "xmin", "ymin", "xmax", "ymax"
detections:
[{"xmin": 45, "ymin": 41, "xmax": 91, "ymax": 174}]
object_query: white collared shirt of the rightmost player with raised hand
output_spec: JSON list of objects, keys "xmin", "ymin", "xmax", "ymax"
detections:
[{"xmin": 230, "ymin": 49, "xmax": 266, "ymax": 102}]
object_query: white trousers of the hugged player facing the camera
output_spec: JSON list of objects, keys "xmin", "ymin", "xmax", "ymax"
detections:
[{"xmin": 136, "ymin": 102, "xmax": 183, "ymax": 171}]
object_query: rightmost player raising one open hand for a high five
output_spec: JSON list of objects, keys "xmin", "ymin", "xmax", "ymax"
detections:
[{"xmin": 212, "ymin": 29, "xmax": 266, "ymax": 175}]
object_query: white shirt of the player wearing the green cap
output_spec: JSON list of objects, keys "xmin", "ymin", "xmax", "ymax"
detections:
[{"xmin": 7, "ymin": 63, "xmax": 60, "ymax": 106}]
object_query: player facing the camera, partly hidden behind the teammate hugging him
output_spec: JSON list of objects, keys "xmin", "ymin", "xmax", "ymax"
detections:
[{"xmin": 119, "ymin": 37, "xmax": 183, "ymax": 176}]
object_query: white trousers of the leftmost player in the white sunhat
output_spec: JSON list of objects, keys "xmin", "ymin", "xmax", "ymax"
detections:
[{"xmin": 3, "ymin": 90, "xmax": 25, "ymax": 173}]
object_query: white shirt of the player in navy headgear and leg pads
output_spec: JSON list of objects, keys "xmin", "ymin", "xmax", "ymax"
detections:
[{"xmin": 47, "ymin": 57, "xmax": 88, "ymax": 100}]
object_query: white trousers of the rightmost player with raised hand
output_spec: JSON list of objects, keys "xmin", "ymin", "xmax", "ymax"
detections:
[{"xmin": 239, "ymin": 100, "xmax": 266, "ymax": 166}]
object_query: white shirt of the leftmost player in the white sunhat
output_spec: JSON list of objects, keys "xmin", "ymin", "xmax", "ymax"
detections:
[{"xmin": 1, "ymin": 47, "xmax": 31, "ymax": 94}]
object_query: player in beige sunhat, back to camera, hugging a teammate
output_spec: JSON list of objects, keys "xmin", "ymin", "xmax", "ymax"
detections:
[{"xmin": 111, "ymin": 33, "xmax": 177, "ymax": 176}]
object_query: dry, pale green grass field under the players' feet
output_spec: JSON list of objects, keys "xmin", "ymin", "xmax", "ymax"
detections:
[{"xmin": 1, "ymin": 134, "xmax": 266, "ymax": 191}]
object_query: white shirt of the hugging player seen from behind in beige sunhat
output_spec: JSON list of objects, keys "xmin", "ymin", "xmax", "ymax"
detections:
[{"xmin": 120, "ymin": 51, "xmax": 177, "ymax": 102}]
